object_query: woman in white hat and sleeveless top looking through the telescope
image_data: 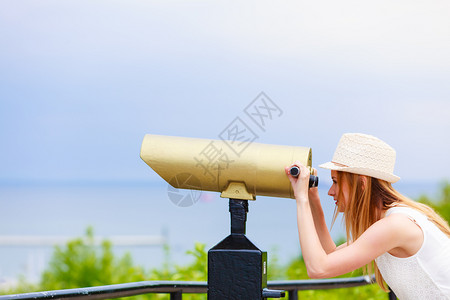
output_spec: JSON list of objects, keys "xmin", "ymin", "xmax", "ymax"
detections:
[{"xmin": 286, "ymin": 133, "xmax": 450, "ymax": 299}]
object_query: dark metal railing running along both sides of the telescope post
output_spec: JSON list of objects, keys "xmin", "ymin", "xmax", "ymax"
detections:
[{"xmin": 0, "ymin": 276, "xmax": 397, "ymax": 300}]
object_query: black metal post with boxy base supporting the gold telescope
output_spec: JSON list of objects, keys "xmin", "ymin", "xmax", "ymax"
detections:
[{"xmin": 208, "ymin": 199, "xmax": 284, "ymax": 300}]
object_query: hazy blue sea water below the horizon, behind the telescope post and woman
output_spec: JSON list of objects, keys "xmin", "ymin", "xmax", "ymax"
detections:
[{"xmin": 0, "ymin": 182, "xmax": 439, "ymax": 284}]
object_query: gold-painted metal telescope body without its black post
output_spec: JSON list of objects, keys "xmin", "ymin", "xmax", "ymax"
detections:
[{"xmin": 141, "ymin": 134, "xmax": 311, "ymax": 200}]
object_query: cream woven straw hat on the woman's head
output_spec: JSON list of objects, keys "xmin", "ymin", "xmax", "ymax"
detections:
[{"xmin": 319, "ymin": 133, "xmax": 400, "ymax": 183}]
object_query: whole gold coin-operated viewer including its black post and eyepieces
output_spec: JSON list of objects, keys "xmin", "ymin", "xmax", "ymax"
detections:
[{"xmin": 141, "ymin": 134, "xmax": 318, "ymax": 300}]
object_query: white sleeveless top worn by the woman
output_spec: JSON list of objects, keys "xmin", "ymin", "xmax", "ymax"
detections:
[{"xmin": 375, "ymin": 207, "xmax": 450, "ymax": 300}]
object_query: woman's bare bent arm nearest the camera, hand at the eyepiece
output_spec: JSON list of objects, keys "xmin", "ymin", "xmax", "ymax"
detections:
[{"xmin": 289, "ymin": 163, "xmax": 410, "ymax": 278}]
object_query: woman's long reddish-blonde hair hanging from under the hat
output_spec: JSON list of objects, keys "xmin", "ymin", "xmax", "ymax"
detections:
[{"xmin": 333, "ymin": 171, "xmax": 450, "ymax": 292}]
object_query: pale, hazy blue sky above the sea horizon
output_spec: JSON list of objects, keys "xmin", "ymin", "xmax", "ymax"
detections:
[{"xmin": 0, "ymin": 0, "xmax": 450, "ymax": 182}]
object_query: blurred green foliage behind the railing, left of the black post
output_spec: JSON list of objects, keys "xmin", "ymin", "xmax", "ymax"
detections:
[{"xmin": 0, "ymin": 228, "xmax": 207, "ymax": 300}]
